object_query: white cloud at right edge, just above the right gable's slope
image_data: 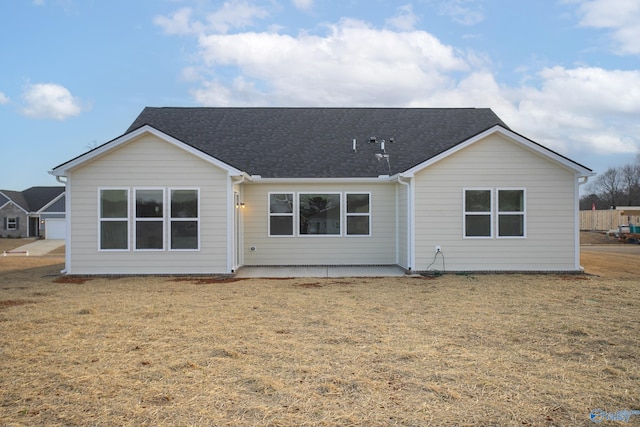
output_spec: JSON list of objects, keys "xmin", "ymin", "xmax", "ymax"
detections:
[{"xmin": 504, "ymin": 67, "xmax": 640, "ymax": 153}]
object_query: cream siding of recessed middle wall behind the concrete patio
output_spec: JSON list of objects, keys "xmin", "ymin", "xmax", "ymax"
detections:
[{"xmin": 242, "ymin": 182, "xmax": 397, "ymax": 265}]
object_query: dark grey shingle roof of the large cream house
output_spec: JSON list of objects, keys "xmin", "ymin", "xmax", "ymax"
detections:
[{"xmin": 127, "ymin": 107, "xmax": 507, "ymax": 178}]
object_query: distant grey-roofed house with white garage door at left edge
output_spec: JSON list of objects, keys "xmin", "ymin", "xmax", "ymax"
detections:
[{"xmin": 0, "ymin": 187, "xmax": 66, "ymax": 239}]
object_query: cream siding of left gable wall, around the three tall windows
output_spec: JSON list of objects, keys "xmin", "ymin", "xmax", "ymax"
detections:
[{"xmin": 67, "ymin": 135, "xmax": 231, "ymax": 274}]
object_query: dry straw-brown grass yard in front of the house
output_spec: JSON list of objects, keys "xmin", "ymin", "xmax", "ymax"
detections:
[{"xmin": 0, "ymin": 236, "xmax": 640, "ymax": 426}]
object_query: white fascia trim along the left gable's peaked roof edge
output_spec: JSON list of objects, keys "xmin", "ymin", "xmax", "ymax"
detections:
[{"xmin": 49, "ymin": 125, "xmax": 243, "ymax": 176}]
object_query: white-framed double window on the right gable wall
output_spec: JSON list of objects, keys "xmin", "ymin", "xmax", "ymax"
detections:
[{"xmin": 464, "ymin": 188, "xmax": 526, "ymax": 238}]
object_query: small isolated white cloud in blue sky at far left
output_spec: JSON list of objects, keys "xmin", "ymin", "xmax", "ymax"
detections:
[{"xmin": 22, "ymin": 83, "xmax": 83, "ymax": 120}]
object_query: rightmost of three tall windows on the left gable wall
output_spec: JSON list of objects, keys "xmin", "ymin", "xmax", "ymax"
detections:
[{"xmin": 169, "ymin": 189, "xmax": 200, "ymax": 250}]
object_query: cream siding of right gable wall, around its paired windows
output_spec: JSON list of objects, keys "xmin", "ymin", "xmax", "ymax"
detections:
[{"xmin": 414, "ymin": 135, "xmax": 577, "ymax": 271}]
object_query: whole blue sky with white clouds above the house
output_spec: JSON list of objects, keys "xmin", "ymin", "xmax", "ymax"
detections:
[{"xmin": 0, "ymin": 0, "xmax": 640, "ymax": 190}]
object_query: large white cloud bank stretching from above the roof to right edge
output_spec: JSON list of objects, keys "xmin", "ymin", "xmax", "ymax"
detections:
[{"xmin": 154, "ymin": 6, "xmax": 640, "ymax": 162}]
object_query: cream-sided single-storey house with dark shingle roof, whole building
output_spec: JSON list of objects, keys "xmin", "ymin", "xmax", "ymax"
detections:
[{"xmin": 51, "ymin": 108, "xmax": 593, "ymax": 274}]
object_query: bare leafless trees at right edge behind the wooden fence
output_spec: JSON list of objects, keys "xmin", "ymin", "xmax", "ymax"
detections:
[{"xmin": 580, "ymin": 154, "xmax": 640, "ymax": 210}]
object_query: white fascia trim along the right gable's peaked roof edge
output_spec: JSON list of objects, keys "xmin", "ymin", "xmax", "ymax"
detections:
[{"xmin": 401, "ymin": 125, "xmax": 596, "ymax": 177}]
